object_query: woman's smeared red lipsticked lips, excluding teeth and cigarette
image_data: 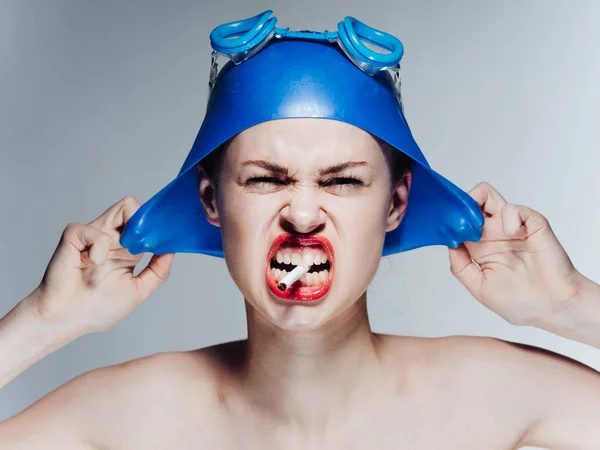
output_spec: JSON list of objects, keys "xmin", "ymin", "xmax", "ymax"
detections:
[{"xmin": 266, "ymin": 233, "xmax": 334, "ymax": 302}]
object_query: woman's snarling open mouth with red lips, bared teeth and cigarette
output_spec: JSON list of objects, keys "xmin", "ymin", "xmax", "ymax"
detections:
[{"xmin": 267, "ymin": 233, "xmax": 333, "ymax": 301}]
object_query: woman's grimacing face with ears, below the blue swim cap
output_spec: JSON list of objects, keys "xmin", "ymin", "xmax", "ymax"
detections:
[{"xmin": 200, "ymin": 119, "xmax": 411, "ymax": 329}]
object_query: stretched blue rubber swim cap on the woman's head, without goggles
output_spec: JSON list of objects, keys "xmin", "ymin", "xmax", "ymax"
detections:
[{"xmin": 120, "ymin": 39, "xmax": 484, "ymax": 257}]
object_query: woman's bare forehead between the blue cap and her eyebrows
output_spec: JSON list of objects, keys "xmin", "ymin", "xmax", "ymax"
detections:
[{"xmin": 227, "ymin": 118, "xmax": 383, "ymax": 166}]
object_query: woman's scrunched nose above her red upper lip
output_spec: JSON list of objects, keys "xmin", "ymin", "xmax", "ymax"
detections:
[{"xmin": 280, "ymin": 188, "xmax": 327, "ymax": 233}]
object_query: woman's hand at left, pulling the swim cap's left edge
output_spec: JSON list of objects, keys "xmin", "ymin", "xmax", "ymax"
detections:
[{"xmin": 33, "ymin": 196, "xmax": 174, "ymax": 336}]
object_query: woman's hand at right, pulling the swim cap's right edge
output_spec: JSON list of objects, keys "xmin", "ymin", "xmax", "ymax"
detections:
[{"xmin": 449, "ymin": 183, "xmax": 582, "ymax": 326}]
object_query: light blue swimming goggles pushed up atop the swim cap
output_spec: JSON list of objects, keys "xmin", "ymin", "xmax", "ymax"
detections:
[{"xmin": 209, "ymin": 10, "xmax": 404, "ymax": 96}]
